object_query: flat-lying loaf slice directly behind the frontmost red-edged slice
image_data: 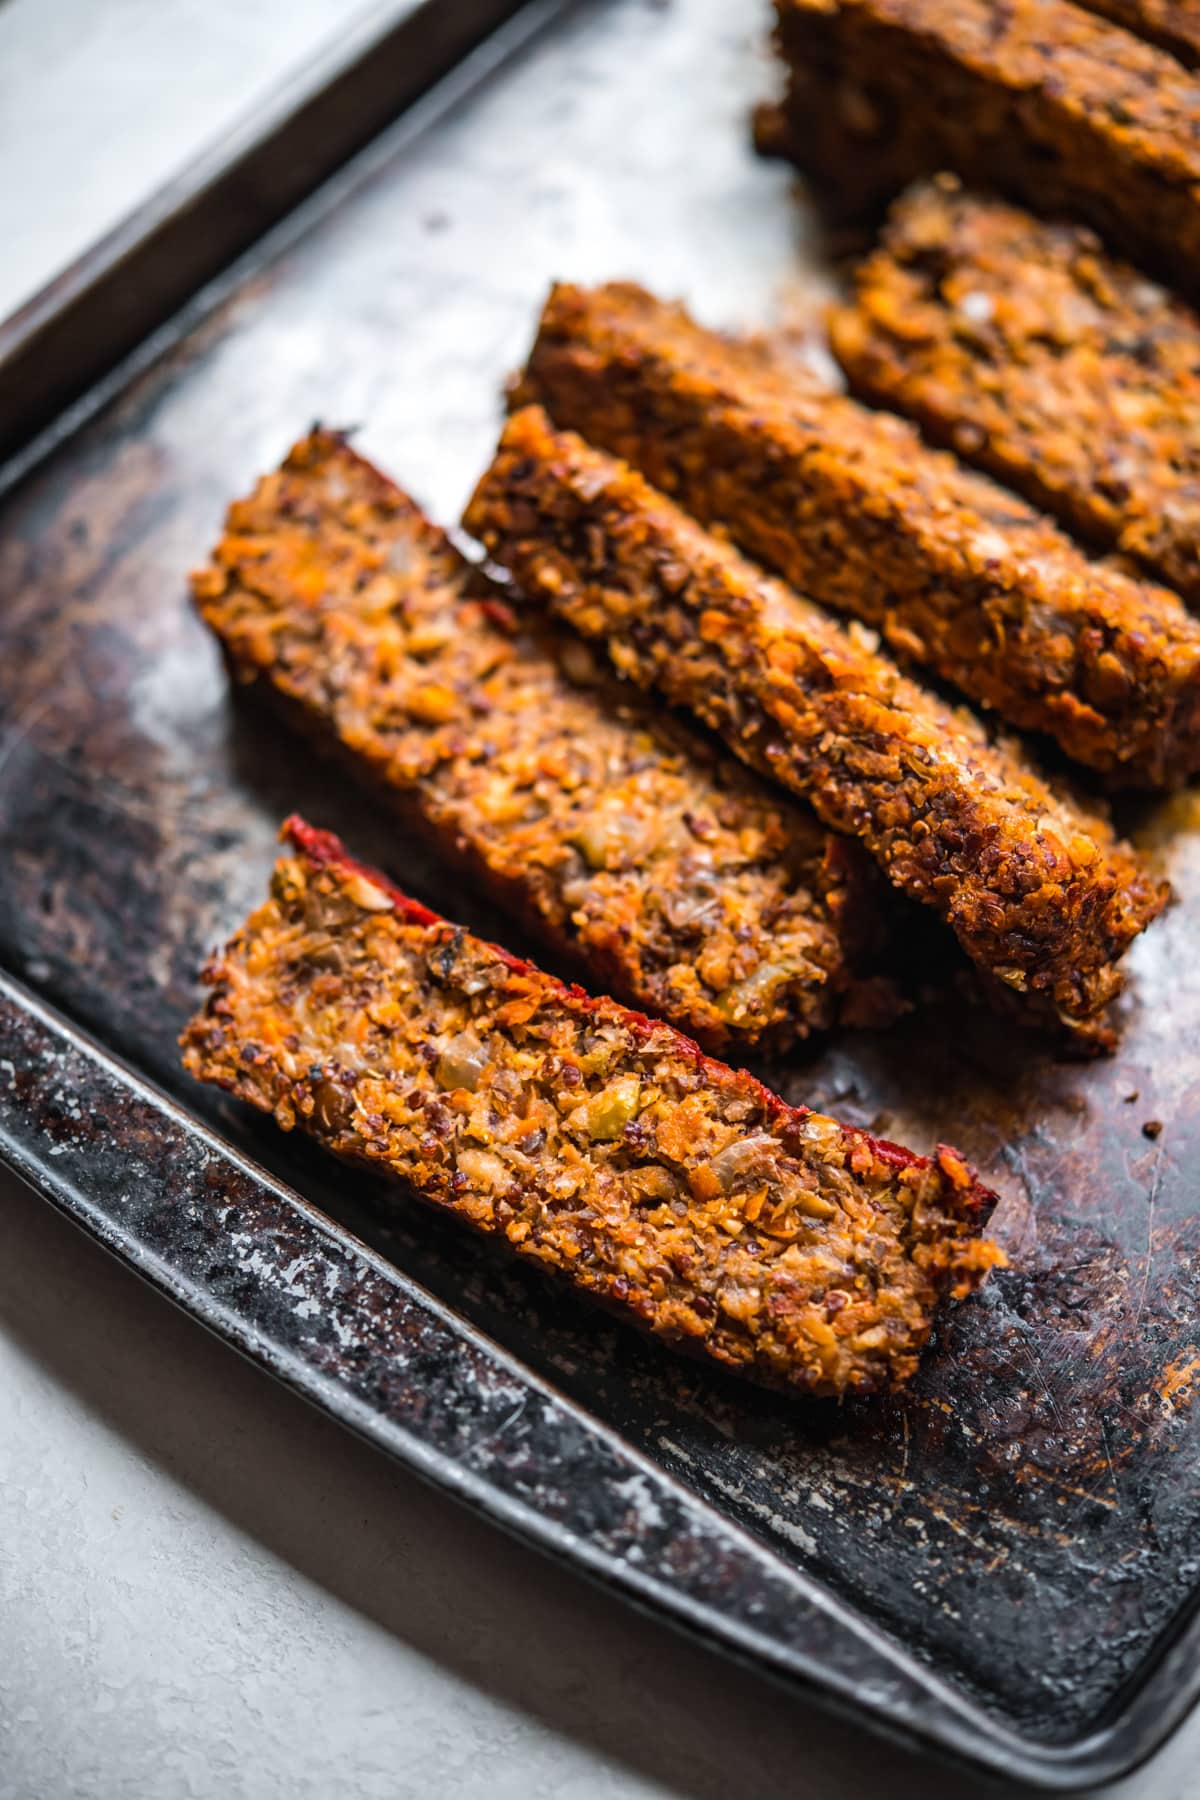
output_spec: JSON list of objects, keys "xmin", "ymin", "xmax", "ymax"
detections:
[{"xmin": 194, "ymin": 432, "xmax": 894, "ymax": 1049}]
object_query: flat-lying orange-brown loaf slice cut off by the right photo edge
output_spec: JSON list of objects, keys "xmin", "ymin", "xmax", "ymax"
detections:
[{"xmin": 829, "ymin": 176, "xmax": 1200, "ymax": 605}]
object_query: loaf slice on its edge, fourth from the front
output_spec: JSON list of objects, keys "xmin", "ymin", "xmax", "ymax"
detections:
[{"xmin": 520, "ymin": 283, "xmax": 1200, "ymax": 787}]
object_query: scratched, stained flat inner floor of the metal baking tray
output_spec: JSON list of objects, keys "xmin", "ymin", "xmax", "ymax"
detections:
[{"xmin": 0, "ymin": 0, "xmax": 1200, "ymax": 1771}]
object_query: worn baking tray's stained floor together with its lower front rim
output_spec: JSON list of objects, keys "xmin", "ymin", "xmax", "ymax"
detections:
[{"xmin": 0, "ymin": 0, "xmax": 1200, "ymax": 1789}]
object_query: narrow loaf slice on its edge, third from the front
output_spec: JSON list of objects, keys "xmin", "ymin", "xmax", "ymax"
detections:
[{"xmin": 466, "ymin": 407, "xmax": 1166, "ymax": 1024}]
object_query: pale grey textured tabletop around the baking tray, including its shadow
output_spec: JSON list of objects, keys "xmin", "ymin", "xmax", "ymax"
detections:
[{"xmin": 0, "ymin": 0, "xmax": 1200, "ymax": 1800}]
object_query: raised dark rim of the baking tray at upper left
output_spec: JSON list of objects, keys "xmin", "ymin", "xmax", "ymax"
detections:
[{"xmin": 0, "ymin": 0, "xmax": 543, "ymax": 493}]
